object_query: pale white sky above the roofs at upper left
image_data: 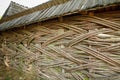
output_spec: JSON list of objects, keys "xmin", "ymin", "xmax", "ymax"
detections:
[{"xmin": 0, "ymin": 0, "xmax": 48, "ymax": 16}]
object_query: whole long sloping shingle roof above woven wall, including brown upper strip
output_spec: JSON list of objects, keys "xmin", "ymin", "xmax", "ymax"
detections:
[{"xmin": 0, "ymin": 0, "xmax": 120, "ymax": 31}]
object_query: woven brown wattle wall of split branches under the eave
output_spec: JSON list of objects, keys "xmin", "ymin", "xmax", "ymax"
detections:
[{"xmin": 0, "ymin": 11, "xmax": 120, "ymax": 80}]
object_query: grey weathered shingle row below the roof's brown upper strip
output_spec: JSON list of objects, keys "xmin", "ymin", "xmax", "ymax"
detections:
[{"xmin": 0, "ymin": 0, "xmax": 120, "ymax": 31}]
